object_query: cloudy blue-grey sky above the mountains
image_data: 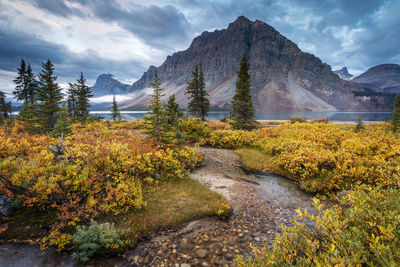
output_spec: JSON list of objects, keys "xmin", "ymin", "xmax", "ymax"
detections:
[{"xmin": 0, "ymin": 0, "xmax": 400, "ymax": 95}]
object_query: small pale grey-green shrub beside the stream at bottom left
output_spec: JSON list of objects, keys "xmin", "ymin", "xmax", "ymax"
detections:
[{"xmin": 72, "ymin": 220, "xmax": 124, "ymax": 262}]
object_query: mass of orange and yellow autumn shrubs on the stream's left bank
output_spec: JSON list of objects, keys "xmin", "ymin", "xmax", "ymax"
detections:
[{"xmin": 0, "ymin": 121, "xmax": 202, "ymax": 249}]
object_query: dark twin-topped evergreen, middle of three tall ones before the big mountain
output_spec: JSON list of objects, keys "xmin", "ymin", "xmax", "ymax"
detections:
[{"xmin": 185, "ymin": 64, "xmax": 210, "ymax": 121}]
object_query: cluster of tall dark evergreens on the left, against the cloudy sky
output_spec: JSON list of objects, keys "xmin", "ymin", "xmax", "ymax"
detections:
[{"xmin": 0, "ymin": 59, "xmax": 97, "ymax": 136}]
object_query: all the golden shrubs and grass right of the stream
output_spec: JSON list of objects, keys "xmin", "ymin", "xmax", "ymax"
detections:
[{"xmin": 173, "ymin": 119, "xmax": 400, "ymax": 266}]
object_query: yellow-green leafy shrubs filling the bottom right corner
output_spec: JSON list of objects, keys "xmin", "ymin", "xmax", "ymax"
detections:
[{"xmin": 234, "ymin": 185, "xmax": 400, "ymax": 266}]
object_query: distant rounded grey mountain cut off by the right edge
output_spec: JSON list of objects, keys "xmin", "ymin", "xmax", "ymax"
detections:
[{"xmin": 351, "ymin": 64, "xmax": 400, "ymax": 94}]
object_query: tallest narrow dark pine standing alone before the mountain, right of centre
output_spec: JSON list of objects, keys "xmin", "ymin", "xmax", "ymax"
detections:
[{"xmin": 231, "ymin": 55, "xmax": 256, "ymax": 130}]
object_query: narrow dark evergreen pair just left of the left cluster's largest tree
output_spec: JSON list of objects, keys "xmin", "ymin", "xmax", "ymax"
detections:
[{"xmin": 13, "ymin": 59, "xmax": 37, "ymax": 104}]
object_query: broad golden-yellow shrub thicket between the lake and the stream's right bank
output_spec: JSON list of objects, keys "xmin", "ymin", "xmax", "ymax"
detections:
[{"xmin": 248, "ymin": 123, "xmax": 400, "ymax": 192}]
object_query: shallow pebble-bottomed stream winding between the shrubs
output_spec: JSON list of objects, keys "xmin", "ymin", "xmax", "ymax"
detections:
[{"xmin": 0, "ymin": 148, "xmax": 318, "ymax": 267}]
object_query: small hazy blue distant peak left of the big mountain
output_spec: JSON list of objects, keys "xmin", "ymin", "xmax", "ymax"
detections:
[{"xmin": 91, "ymin": 73, "xmax": 132, "ymax": 97}]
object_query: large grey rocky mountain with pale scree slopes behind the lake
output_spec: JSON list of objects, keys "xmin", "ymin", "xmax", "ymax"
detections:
[{"xmin": 124, "ymin": 17, "xmax": 388, "ymax": 111}]
